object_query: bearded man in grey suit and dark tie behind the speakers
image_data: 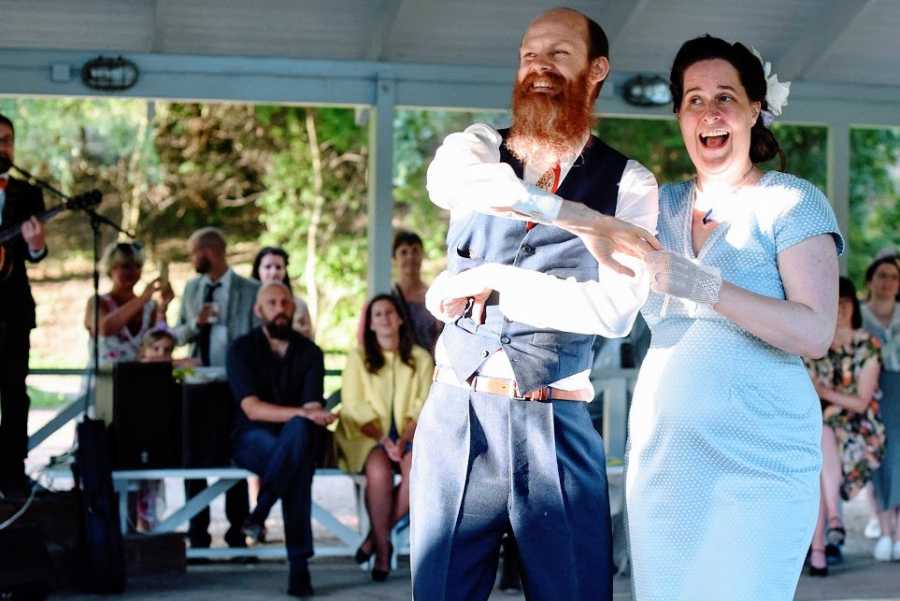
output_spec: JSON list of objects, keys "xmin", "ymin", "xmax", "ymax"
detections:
[{"xmin": 175, "ymin": 227, "xmax": 259, "ymax": 548}]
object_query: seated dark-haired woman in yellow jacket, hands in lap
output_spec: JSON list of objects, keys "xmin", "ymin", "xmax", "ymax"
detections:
[{"xmin": 335, "ymin": 294, "xmax": 434, "ymax": 581}]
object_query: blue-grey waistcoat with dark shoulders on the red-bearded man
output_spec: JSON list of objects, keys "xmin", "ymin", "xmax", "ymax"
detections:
[{"xmin": 442, "ymin": 130, "xmax": 627, "ymax": 393}]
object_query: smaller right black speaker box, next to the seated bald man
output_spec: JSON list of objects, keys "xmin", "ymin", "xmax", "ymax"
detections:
[{"xmin": 181, "ymin": 381, "xmax": 234, "ymax": 468}]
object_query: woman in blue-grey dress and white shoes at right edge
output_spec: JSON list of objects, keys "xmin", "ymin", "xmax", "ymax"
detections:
[{"xmin": 862, "ymin": 256, "xmax": 900, "ymax": 561}]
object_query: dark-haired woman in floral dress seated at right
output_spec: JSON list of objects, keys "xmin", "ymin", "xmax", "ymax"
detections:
[{"xmin": 807, "ymin": 277, "xmax": 884, "ymax": 576}]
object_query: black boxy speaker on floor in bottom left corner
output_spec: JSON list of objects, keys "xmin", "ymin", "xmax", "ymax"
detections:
[{"xmin": 0, "ymin": 525, "xmax": 52, "ymax": 601}]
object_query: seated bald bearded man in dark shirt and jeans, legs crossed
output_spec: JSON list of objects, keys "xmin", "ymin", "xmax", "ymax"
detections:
[{"xmin": 227, "ymin": 282, "xmax": 336, "ymax": 597}]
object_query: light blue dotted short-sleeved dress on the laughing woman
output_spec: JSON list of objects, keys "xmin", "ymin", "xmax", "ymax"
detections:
[{"xmin": 626, "ymin": 171, "xmax": 843, "ymax": 601}]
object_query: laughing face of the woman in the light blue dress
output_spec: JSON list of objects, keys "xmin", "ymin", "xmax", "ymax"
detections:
[{"xmin": 678, "ymin": 59, "xmax": 760, "ymax": 182}]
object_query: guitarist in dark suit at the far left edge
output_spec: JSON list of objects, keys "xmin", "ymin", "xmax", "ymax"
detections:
[{"xmin": 0, "ymin": 114, "xmax": 47, "ymax": 497}]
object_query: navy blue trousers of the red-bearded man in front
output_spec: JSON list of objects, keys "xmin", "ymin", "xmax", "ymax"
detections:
[{"xmin": 410, "ymin": 382, "xmax": 613, "ymax": 601}]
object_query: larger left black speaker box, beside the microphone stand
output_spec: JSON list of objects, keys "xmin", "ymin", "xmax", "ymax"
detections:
[{"xmin": 110, "ymin": 362, "xmax": 181, "ymax": 469}]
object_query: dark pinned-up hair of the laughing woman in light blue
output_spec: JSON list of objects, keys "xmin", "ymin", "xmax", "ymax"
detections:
[{"xmin": 669, "ymin": 34, "xmax": 787, "ymax": 171}]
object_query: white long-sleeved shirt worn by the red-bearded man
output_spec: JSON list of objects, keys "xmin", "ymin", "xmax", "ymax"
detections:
[{"xmin": 427, "ymin": 123, "xmax": 659, "ymax": 390}]
